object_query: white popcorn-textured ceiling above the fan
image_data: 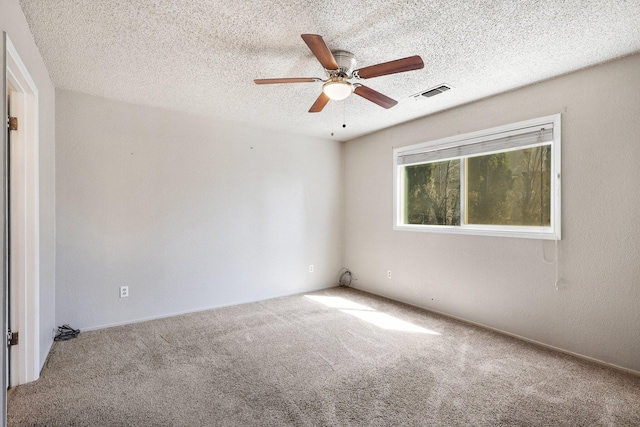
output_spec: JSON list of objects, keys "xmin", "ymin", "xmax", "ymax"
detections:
[{"xmin": 20, "ymin": 0, "xmax": 640, "ymax": 140}]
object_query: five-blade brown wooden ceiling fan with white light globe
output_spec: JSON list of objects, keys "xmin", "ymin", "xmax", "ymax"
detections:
[{"xmin": 254, "ymin": 34, "xmax": 424, "ymax": 113}]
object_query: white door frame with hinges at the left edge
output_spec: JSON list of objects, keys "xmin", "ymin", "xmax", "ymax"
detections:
[{"xmin": 3, "ymin": 33, "xmax": 40, "ymax": 390}]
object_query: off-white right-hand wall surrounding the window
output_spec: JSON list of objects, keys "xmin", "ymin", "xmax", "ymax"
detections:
[{"xmin": 344, "ymin": 55, "xmax": 640, "ymax": 371}]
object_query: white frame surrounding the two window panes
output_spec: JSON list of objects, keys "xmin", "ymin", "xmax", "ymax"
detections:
[{"xmin": 393, "ymin": 114, "xmax": 561, "ymax": 240}]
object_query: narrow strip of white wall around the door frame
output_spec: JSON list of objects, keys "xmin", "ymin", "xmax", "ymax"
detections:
[{"xmin": 0, "ymin": 0, "xmax": 55, "ymax": 372}]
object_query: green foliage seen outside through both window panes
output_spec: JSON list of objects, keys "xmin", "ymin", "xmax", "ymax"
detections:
[{"xmin": 405, "ymin": 145, "xmax": 551, "ymax": 227}]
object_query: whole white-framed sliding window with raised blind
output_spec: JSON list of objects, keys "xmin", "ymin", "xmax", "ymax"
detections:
[{"xmin": 393, "ymin": 114, "xmax": 560, "ymax": 239}]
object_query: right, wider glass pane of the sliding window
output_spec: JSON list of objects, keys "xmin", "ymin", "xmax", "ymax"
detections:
[{"xmin": 466, "ymin": 145, "xmax": 551, "ymax": 227}]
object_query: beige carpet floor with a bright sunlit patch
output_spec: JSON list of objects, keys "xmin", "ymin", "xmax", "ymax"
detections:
[{"xmin": 8, "ymin": 288, "xmax": 640, "ymax": 426}]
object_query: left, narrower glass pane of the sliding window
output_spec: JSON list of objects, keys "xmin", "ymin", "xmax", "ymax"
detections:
[{"xmin": 404, "ymin": 159, "xmax": 460, "ymax": 225}]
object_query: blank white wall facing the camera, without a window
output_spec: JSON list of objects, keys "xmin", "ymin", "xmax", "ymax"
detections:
[{"xmin": 56, "ymin": 90, "xmax": 343, "ymax": 329}]
